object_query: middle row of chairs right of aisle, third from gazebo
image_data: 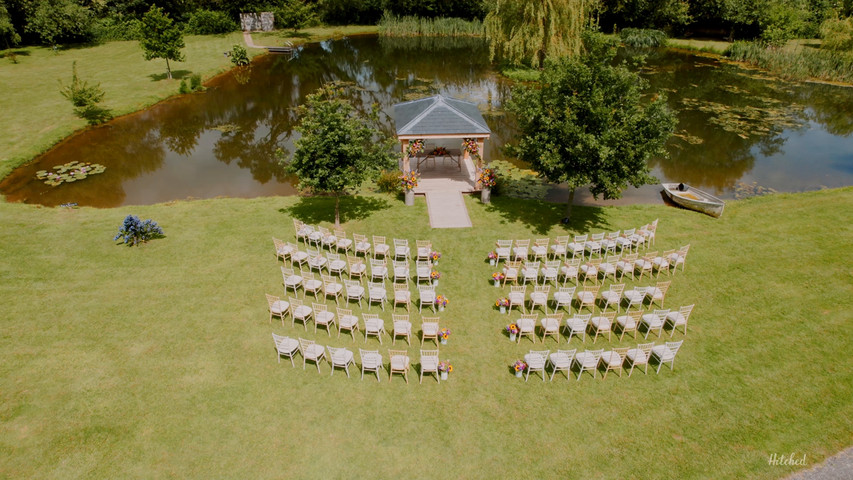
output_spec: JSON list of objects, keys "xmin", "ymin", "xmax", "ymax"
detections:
[{"xmin": 507, "ymin": 280, "xmax": 672, "ymax": 314}]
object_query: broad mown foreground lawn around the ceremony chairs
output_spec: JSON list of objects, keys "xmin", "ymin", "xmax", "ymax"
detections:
[{"xmin": 0, "ymin": 188, "xmax": 853, "ymax": 478}]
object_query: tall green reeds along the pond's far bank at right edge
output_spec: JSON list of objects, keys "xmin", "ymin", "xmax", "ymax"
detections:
[{"xmin": 725, "ymin": 42, "xmax": 853, "ymax": 83}]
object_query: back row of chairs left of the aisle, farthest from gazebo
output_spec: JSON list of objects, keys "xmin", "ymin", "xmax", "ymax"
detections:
[{"xmin": 272, "ymin": 333, "xmax": 441, "ymax": 384}]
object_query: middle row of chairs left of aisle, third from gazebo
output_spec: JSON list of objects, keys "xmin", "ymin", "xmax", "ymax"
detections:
[{"xmin": 281, "ymin": 267, "xmax": 439, "ymax": 312}]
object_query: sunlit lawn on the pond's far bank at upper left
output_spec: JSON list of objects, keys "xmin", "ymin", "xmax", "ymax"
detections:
[{"xmin": 0, "ymin": 27, "xmax": 376, "ymax": 184}]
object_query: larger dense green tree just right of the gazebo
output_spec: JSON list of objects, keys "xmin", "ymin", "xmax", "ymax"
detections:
[{"xmin": 508, "ymin": 34, "xmax": 676, "ymax": 222}]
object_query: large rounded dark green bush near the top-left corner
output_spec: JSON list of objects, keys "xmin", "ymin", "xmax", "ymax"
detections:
[{"xmin": 26, "ymin": 0, "xmax": 94, "ymax": 45}]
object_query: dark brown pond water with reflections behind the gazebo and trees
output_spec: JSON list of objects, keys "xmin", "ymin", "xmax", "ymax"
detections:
[{"xmin": 0, "ymin": 33, "xmax": 853, "ymax": 207}]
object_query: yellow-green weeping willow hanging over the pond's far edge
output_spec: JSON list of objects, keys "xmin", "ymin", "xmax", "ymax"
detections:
[{"xmin": 484, "ymin": 0, "xmax": 594, "ymax": 68}]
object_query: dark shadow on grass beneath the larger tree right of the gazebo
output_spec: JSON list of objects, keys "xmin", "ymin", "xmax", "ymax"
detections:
[{"xmin": 486, "ymin": 197, "xmax": 607, "ymax": 235}]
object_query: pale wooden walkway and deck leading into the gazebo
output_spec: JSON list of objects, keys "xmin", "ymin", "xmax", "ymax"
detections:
[{"xmin": 408, "ymin": 157, "xmax": 477, "ymax": 228}]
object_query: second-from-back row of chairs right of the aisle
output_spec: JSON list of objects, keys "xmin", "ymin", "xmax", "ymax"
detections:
[{"xmin": 515, "ymin": 304, "xmax": 694, "ymax": 344}]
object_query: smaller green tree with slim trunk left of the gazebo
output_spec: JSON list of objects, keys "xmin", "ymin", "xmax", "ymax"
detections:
[{"xmin": 287, "ymin": 84, "xmax": 395, "ymax": 225}]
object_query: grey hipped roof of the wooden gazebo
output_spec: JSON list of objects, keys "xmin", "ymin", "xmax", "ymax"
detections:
[{"xmin": 394, "ymin": 95, "xmax": 492, "ymax": 138}]
